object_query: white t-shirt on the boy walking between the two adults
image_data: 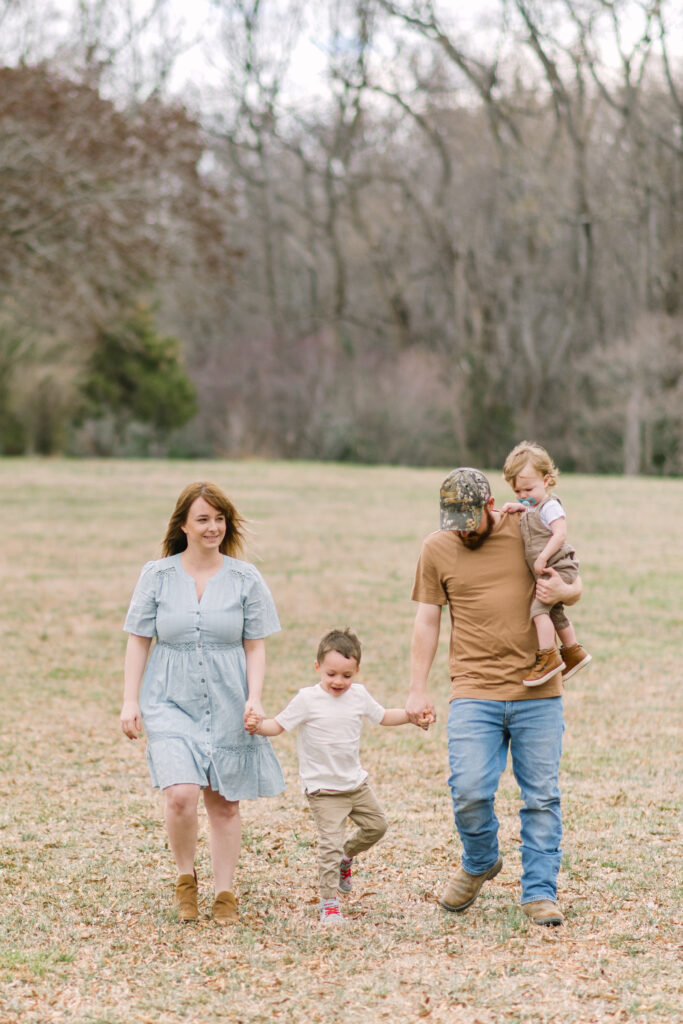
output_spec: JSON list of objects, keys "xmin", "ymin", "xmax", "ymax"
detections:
[{"xmin": 275, "ymin": 683, "xmax": 385, "ymax": 793}]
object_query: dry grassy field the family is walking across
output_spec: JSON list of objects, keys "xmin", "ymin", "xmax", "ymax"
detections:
[{"xmin": 0, "ymin": 460, "xmax": 683, "ymax": 1024}]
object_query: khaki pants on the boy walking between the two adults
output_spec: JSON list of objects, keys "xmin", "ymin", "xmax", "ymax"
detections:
[{"xmin": 306, "ymin": 782, "xmax": 387, "ymax": 899}]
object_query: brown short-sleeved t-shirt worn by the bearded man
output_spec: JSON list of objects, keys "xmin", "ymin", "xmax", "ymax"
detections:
[{"xmin": 412, "ymin": 513, "xmax": 562, "ymax": 700}]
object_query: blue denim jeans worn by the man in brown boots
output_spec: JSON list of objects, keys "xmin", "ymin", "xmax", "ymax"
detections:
[{"xmin": 447, "ymin": 697, "xmax": 564, "ymax": 903}]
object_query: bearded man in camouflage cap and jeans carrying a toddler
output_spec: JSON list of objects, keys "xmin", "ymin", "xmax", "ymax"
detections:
[{"xmin": 405, "ymin": 468, "xmax": 582, "ymax": 925}]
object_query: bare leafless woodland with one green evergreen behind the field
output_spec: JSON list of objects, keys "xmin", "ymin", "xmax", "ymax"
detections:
[{"xmin": 0, "ymin": 0, "xmax": 683, "ymax": 474}]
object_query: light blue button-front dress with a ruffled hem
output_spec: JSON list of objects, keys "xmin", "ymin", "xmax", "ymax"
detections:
[{"xmin": 124, "ymin": 554, "xmax": 285, "ymax": 800}]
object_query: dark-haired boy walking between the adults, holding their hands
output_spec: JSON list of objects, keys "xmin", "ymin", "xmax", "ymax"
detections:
[{"xmin": 245, "ymin": 629, "xmax": 417, "ymax": 925}]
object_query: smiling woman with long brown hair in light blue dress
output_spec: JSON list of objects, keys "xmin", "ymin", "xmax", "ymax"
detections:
[{"xmin": 121, "ymin": 483, "xmax": 285, "ymax": 925}]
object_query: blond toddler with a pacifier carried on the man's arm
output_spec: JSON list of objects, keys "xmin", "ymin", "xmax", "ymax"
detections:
[{"xmin": 502, "ymin": 441, "xmax": 592, "ymax": 686}]
